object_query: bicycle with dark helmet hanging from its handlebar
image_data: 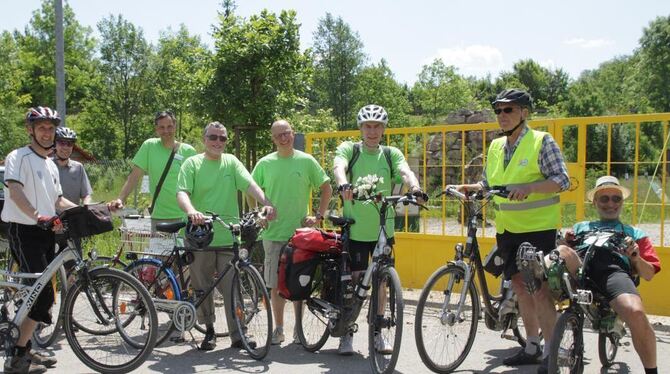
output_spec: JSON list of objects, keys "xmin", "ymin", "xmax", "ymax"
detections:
[{"xmin": 126, "ymin": 211, "xmax": 272, "ymax": 360}]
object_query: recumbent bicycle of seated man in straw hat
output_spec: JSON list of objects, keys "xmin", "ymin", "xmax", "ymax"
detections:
[{"xmin": 547, "ymin": 229, "xmax": 627, "ymax": 373}]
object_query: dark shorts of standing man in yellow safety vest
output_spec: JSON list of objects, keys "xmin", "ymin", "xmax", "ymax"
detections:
[{"xmin": 496, "ymin": 230, "xmax": 556, "ymax": 278}]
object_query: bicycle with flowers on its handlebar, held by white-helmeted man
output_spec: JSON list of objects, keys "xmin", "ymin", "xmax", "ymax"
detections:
[{"xmin": 296, "ymin": 194, "xmax": 422, "ymax": 373}]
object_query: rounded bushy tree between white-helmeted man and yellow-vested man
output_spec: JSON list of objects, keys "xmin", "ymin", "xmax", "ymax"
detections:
[{"xmin": 412, "ymin": 59, "xmax": 475, "ymax": 122}]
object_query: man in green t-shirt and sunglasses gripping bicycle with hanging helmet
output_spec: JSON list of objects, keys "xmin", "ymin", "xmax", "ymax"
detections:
[{"xmin": 177, "ymin": 122, "xmax": 275, "ymax": 350}]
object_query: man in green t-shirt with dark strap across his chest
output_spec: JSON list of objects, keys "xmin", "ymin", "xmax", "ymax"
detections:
[{"xmin": 110, "ymin": 111, "xmax": 196, "ymax": 230}]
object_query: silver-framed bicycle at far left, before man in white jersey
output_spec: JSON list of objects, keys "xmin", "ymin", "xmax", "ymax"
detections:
[{"xmin": 0, "ymin": 207, "xmax": 157, "ymax": 373}]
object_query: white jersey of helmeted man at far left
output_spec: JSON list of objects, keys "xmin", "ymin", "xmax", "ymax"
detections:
[{"xmin": 2, "ymin": 146, "xmax": 63, "ymax": 225}]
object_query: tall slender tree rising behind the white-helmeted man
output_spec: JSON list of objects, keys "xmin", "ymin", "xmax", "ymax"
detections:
[{"xmin": 313, "ymin": 13, "xmax": 365, "ymax": 130}]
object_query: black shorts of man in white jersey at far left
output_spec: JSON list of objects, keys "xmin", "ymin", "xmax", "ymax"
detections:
[{"xmin": 8, "ymin": 222, "xmax": 56, "ymax": 323}]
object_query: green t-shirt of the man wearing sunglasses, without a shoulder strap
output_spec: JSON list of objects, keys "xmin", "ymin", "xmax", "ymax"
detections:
[{"xmin": 177, "ymin": 153, "xmax": 253, "ymax": 247}]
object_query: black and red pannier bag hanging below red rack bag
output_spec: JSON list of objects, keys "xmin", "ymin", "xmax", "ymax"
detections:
[{"xmin": 277, "ymin": 244, "xmax": 321, "ymax": 301}]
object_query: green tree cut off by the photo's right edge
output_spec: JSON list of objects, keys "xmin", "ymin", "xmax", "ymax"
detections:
[{"xmin": 640, "ymin": 17, "xmax": 670, "ymax": 112}]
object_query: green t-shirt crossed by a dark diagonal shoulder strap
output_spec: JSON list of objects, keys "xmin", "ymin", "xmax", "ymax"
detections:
[{"xmin": 133, "ymin": 138, "xmax": 196, "ymax": 219}]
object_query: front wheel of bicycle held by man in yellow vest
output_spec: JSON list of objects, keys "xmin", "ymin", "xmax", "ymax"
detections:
[{"xmin": 414, "ymin": 264, "xmax": 480, "ymax": 373}]
